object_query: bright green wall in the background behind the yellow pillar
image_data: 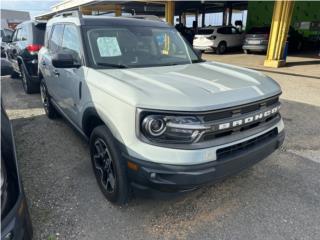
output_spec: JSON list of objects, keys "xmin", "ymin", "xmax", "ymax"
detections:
[{"xmin": 247, "ymin": 1, "xmax": 320, "ymax": 35}]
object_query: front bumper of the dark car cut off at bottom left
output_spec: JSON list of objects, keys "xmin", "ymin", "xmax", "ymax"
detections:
[{"xmin": 1, "ymin": 194, "xmax": 32, "ymax": 240}]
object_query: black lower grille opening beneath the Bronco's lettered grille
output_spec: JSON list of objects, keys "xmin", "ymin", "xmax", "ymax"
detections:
[{"xmin": 217, "ymin": 128, "xmax": 278, "ymax": 161}]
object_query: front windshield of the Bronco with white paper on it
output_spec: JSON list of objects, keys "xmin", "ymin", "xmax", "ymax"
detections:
[{"xmin": 87, "ymin": 26, "xmax": 201, "ymax": 68}]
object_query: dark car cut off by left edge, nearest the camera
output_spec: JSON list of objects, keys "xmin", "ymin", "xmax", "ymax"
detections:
[{"xmin": 0, "ymin": 59, "xmax": 32, "ymax": 240}]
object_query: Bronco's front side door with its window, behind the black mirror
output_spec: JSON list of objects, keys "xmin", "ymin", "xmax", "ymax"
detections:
[{"xmin": 58, "ymin": 24, "xmax": 84, "ymax": 124}]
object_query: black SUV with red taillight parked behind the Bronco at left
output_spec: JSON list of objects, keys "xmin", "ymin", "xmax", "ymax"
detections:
[{"xmin": 7, "ymin": 20, "xmax": 46, "ymax": 93}]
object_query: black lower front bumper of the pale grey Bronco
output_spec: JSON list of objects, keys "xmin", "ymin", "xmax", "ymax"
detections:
[{"xmin": 124, "ymin": 128, "xmax": 285, "ymax": 192}]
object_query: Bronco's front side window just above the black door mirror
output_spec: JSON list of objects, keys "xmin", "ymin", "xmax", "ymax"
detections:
[{"xmin": 62, "ymin": 24, "xmax": 80, "ymax": 58}]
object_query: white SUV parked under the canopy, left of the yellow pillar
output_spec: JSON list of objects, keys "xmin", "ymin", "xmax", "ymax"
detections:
[{"xmin": 193, "ymin": 26, "xmax": 244, "ymax": 54}]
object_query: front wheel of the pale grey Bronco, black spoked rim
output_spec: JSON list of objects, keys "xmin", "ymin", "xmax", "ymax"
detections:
[{"xmin": 90, "ymin": 125, "xmax": 130, "ymax": 205}]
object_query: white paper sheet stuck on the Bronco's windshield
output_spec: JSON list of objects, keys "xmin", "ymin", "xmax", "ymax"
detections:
[{"xmin": 97, "ymin": 37, "xmax": 121, "ymax": 57}]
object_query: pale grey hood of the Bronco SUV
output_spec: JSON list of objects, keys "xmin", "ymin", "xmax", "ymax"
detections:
[{"xmin": 95, "ymin": 62, "xmax": 281, "ymax": 111}]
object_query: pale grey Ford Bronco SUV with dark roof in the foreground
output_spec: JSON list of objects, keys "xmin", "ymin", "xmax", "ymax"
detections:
[{"xmin": 39, "ymin": 13, "xmax": 284, "ymax": 204}]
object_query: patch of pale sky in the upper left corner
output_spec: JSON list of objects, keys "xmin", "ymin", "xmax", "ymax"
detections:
[{"xmin": 1, "ymin": 0, "xmax": 61, "ymax": 18}]
